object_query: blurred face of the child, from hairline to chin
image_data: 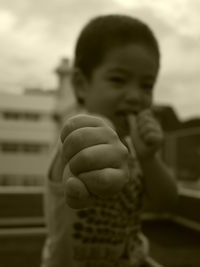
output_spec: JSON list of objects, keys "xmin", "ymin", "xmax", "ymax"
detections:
[{"xmin": 80, "ymin": 44, "xmax": 158, "ymax": 136}]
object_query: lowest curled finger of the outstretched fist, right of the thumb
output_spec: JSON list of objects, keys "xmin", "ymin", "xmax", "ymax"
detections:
[{"xmin": 79, "ymin": 168, "xmax": 130, "ymax": 198}]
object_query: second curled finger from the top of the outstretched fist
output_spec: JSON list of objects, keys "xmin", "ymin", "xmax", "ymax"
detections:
[{"xmin": 62, "ymin": 126, "xmax": 119, "ymax": 162}]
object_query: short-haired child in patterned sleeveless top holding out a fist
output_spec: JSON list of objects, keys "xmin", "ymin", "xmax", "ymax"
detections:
[{"xmin": 42, "ymin": 15, "xmax": 177, "ymax": 267}]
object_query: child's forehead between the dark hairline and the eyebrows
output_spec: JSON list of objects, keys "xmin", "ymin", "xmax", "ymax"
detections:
[{"xmin": 101, "ymin": 44, "xmax": 159, "ymax": 77}]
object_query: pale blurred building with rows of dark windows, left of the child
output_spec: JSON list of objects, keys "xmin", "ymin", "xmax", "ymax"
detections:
[{"xmin": 0, "ymin": 93, "xmax": 57, "ymax": 186}]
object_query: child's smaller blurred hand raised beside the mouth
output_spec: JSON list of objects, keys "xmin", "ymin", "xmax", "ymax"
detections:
[{"xmin": 128, "ymin": 110, "xmax": 163, "ymax": 160}]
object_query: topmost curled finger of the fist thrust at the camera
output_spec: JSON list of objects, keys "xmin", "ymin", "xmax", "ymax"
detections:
[{"xmin": 60, "ymin": 114, "xmax": 110, "ymax": 143}]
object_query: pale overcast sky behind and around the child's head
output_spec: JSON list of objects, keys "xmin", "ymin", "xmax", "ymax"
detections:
[{"xmin": 0, "ymin": 0, "xmax": 200, "ymax": 118}]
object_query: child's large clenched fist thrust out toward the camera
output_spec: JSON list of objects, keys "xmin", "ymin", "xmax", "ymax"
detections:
[{"xmin": 61, "ymin": 115, "xmax": 129, "ymax": 208}]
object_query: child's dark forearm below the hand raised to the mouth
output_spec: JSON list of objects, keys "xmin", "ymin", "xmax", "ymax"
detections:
[{"xmin": 140, "ymin": 156, "xmax": 178, "ymax": 213}]
